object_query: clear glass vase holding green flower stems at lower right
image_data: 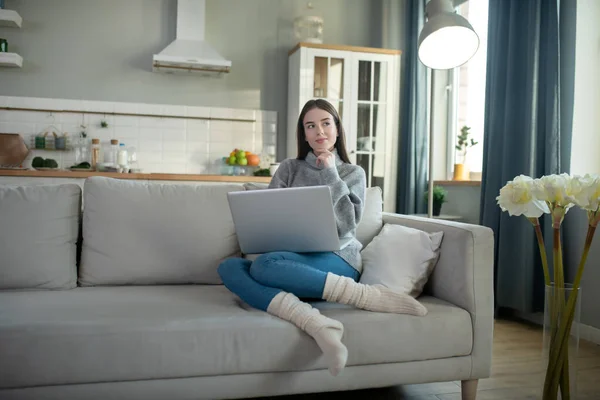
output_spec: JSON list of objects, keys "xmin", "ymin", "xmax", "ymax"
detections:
[{"xmin": 541, "ymin": 284, "xmax": 581, "ymax": 400}]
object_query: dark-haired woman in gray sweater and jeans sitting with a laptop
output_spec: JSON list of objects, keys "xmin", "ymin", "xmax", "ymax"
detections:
[{"xmin": 219, "ymin": 99, "xmax": 427, "ymax": 376}]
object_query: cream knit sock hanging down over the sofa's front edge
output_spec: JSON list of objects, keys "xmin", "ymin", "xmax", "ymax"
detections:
[{"xmin": 267, "ymin": 291, "xmax": 348, "ymax": 376}]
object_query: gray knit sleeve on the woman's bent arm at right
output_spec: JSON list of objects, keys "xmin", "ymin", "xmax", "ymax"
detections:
[{"xmin": 321, "ymin": 167, "xmax": 367, "ymax": 237}]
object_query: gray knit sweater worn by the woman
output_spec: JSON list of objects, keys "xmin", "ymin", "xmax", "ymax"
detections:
[{"xmin": 269, "ymin": 150, "xmax": 367, "ymax": 273}]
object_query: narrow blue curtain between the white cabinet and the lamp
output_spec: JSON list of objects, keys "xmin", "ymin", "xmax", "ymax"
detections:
[{"xmin": 396, "ymin": 0, "xmax": 428, "ymax": 214}]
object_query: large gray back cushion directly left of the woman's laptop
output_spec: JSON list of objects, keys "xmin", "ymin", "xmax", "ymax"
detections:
[{"xmin": 79, "ymin": 177, "xmax": 244, "ymax": 286}]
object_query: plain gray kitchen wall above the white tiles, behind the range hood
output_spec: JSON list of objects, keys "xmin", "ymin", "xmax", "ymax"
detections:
[{"xmin": 0, "ymin": 0, "xmax": 381, "ymax": 159}]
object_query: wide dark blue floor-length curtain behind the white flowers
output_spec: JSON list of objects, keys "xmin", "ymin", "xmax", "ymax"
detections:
[{"xmin": 480, "ymin": 0, "xmax": 576, "ymax": 313}]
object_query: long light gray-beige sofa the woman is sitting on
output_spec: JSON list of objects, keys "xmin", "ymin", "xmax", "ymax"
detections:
[{"xmin": 0, "ymin": 177, "xmax": 493, "ymax": 400}]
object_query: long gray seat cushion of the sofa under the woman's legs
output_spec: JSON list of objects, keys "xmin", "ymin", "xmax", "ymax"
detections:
[{"xmin": 0, "ymin": 285, "xmax": 472, "ymax": 388}]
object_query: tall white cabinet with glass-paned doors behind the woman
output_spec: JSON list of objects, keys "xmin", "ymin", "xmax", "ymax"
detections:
[{"xmin": 286, "ymin": 43, "xmax": 401, "ymax": 212}]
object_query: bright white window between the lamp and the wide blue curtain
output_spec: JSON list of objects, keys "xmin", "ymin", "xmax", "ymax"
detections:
[{"xmin": 448, "ymin": 0, "xmax": 488, "ymax": 176}]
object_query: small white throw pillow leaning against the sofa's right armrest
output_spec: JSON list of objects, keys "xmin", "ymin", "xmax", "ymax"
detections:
[{"xmin": 360, "ymin": 224, "xmax": 444, "ymax": 297}]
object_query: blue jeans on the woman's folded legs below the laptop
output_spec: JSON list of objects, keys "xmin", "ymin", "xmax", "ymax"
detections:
[{"xmin": 218, "ymin": 251, "xmax": 360, "ymax": 311}]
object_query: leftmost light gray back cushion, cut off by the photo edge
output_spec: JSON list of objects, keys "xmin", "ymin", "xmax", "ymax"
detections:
[{"xmin": 0, "ymin": 184, "xmax": 81, "ymax": 289}]
